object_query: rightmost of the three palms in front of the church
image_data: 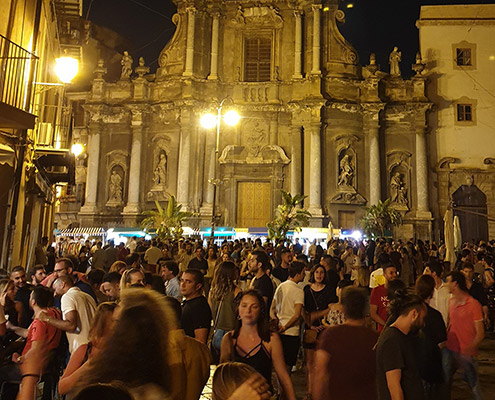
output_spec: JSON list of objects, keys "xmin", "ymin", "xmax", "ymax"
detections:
[{"xmin": 360, "ymin": 199, "xmax": 402, "ymax": 237}]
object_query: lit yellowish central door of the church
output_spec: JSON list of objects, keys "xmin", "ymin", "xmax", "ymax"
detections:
[{"xmin": 236, "ymin": 181, "xmax": 272, "ymax": 228}]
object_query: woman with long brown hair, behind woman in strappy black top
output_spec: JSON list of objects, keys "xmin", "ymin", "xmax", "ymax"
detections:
[{"xmin": 208, "ymin": 261, "xmax": 241, "ymax": 354}]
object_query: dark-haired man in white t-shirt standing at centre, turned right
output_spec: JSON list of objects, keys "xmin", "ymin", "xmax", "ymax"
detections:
[{"xmin": 270, "ymin": 261, "xmax": 306, "ymax": 372}]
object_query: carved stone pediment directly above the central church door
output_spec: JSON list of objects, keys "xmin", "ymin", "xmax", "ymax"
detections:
[{"xmin": 218, "ymin": 144, "xmax": 290, "ymax": 164}]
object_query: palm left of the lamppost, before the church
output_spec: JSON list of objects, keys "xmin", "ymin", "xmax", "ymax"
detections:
[{"xmin": 141, "ymin": 196, "xmax": 192, "ymax": 240}]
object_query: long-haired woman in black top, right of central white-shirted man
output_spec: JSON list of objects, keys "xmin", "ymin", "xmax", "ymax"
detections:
[{"xmin": 303, "ymin": 264, "xmax": 334, "ymax": 393}]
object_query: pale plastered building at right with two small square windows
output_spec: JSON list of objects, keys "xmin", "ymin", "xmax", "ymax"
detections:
[{"xmin": 418, "ymin": 5, "xmax": 495, "ymax": 241}]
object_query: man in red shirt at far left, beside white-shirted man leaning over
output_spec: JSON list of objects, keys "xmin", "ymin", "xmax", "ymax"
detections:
[{"xmin": 0, "ymin": 286, "xmax": 61, "ymax": 382}]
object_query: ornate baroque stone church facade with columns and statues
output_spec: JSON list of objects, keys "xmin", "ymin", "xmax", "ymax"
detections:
[{"xmin": 68, "ymin": 0, "xmax": 433, "ymax": 239}]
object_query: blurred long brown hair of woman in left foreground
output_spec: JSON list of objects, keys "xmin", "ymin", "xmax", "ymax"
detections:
[{"xmin": 79, "ymin": 288, "xmax": 175, "ymax": 400}]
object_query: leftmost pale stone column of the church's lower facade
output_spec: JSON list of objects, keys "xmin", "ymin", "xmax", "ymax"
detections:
[{"xmin": 81, "ymin": 123, "xmax": 101, "ymax": 214}]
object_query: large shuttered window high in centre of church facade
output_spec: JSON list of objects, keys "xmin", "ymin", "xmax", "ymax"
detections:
[{"xmin": 244, "ymin": 38, "xmax": 272, "ymax": 82}]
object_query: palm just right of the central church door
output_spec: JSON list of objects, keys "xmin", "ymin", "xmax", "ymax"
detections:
[{"xmin": 266, "ymin": 190, "xmax": 311, "ymax": 240}]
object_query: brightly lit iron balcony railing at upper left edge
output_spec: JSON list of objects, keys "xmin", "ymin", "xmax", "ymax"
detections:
[{"xmin": 0, "ymin": 35, "xmax": 38, "ymax": 111}]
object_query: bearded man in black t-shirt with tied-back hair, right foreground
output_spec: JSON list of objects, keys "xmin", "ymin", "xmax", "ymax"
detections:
[{"xmin": 376, "ymin": 293, "xmax": 427, "ymax": 400}]
